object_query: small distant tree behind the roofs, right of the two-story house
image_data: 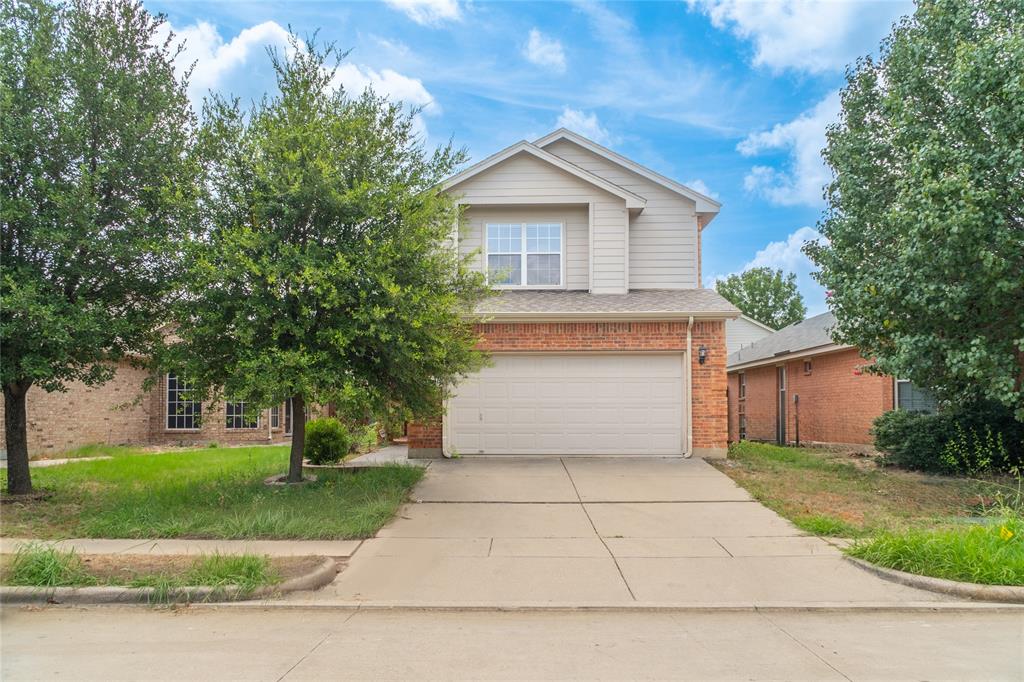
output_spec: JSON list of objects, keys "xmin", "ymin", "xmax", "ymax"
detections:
[{"xmin": 715, "ymin": 267, "xmax": 807, "ymax": 329}]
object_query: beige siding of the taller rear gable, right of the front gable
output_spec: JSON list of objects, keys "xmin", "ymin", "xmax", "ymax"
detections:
[{"xmin": 544, "ymin": 140, "xmax": 699, "ymax": 289}]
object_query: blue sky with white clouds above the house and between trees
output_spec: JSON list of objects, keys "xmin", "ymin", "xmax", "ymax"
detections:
[{"xmin": 145, "ymin": 0, "xmax": 912, "ymax": 314}]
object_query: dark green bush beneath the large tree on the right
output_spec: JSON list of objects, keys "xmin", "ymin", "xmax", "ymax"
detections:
[{"xmin": 872, "ymin": 402, "xmax": 1024, "ymax": 476}]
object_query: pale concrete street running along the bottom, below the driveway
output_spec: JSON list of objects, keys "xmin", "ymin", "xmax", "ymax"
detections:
[{"xmin": 0, "ymin": 607, "xmax": 1024, "ymax": 682}]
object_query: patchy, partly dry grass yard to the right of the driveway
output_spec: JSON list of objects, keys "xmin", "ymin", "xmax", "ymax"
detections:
[{"xmin": 716, "ymin": 441, "xmax": 1024, "ymax": 585}]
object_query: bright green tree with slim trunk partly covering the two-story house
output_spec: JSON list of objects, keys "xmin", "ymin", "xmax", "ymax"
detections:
[{"xmin": 170, "ymin": 37, "xmax": 486, "ymax": 482}]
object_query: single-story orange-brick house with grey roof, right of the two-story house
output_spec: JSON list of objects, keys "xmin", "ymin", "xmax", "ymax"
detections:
[{"xmin": 728, "ymin": 312, "xmax": 935, "ymax": 444}]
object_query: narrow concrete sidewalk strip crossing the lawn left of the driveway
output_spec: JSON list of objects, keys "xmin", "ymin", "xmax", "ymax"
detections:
[{"xmin": 0, "ymin": 538, "xmax": 360, "ymax": 558}]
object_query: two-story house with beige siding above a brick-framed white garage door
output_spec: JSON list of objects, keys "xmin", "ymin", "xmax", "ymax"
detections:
[{"xmin": 410, "ymin": 129, "xmax": 739, "ymax": 457}]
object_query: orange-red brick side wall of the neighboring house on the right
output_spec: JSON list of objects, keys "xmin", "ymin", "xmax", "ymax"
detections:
[{"xmin": 729, "ymin": 348, "xmax": 893, "ymax": 444}]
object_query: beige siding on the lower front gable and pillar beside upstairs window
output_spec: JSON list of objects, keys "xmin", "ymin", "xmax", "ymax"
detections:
[{"xmin": 451, "ymin": 154, "xmax": 629, "ymax": 293}]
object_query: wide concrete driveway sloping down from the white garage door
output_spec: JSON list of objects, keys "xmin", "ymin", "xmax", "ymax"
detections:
[{"xmin": 292, "ymin": 457, "xmax": 944, "ymax": 606}]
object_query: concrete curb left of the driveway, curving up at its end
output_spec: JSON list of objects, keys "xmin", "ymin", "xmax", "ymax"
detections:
[{"xmin": 0, "ymin": 558, "xmax": 338, "ymax": 605}]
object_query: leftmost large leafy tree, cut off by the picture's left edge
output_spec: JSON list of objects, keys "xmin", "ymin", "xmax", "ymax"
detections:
[{"xmin": 0, "ymin": 0, "xmax": 197, "ymax": 494}]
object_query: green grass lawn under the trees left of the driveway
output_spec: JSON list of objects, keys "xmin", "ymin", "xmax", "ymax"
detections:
[{"xmin": 0, "ymin": 446, "xmax": 423, "ymax": 540}]
